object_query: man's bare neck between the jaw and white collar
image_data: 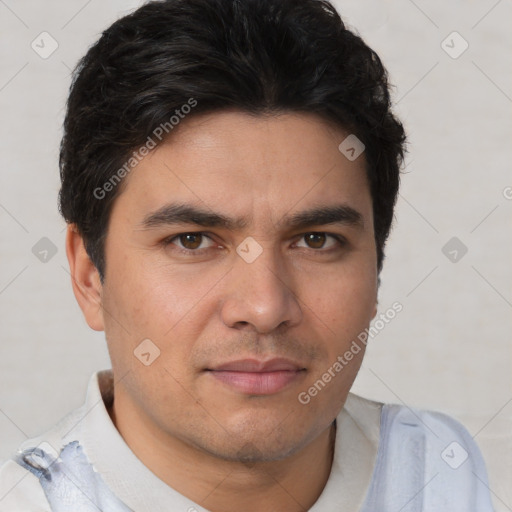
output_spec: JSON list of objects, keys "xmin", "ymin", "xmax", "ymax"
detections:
[{"xmin": 109, "ymin": 397, "xmax": 336, "ymax": 512}]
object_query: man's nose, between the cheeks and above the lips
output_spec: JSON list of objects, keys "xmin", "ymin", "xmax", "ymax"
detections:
[{"xmin": 221, "ymin": 248, "xmax": 302, "ymax": 334}]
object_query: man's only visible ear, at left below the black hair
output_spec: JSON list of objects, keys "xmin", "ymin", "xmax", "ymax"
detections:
[{"xmin": 66, "ymin": 224, "xmax": 105, "ymax": 331}]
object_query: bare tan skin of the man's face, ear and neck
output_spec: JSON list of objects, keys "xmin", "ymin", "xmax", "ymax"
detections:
[{"xmin": 67, "ymin": 112, "xmax": 377, "ymax": 512}]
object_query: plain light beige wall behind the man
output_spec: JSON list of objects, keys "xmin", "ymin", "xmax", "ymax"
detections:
[{"xmin": 0, "ymin": 0, "xmax": 512, "ymax": 511}]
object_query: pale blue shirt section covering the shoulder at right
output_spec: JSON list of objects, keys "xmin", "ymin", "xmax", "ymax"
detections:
[{"xmin": 356, "ymin": 404, "xmax": 493, "ymax": 512}]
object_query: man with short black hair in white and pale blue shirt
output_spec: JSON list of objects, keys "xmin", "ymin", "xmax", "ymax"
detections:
[{"xmin": 0, "ymin": 0, "xmax": 492, "ymax": 512}]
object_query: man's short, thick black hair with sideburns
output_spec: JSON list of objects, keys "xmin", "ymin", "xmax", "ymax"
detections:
[{"xmin": 59, "ymin": 0, "xmax": 405, "ymax": 279}]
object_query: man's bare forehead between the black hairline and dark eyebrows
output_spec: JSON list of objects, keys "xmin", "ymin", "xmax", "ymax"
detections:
[{"xmin": 114, "ymin": 112, "xmax": 371, "ymax": 229}]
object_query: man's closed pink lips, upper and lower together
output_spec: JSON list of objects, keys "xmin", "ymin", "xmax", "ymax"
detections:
[{"xmin": 207, "ymin": 359, "xmax": 305, "ymax": 395}]
